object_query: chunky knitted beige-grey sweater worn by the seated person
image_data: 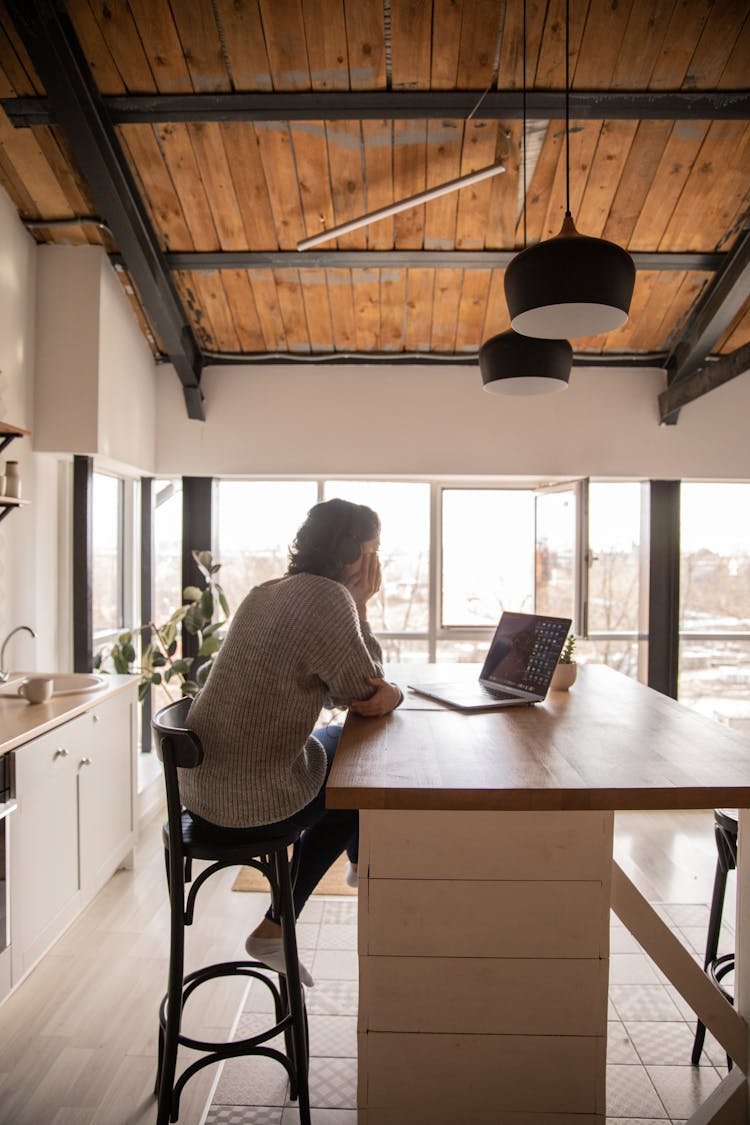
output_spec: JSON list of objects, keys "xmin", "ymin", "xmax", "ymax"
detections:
[{"xmin": 180, "ymin": 574, "xmax": 382, "ymax": 828}]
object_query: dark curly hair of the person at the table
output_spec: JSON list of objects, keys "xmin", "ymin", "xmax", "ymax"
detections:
[{"xmin": 287, "ymin": 500, "xmax": 380, "ymax": 582}]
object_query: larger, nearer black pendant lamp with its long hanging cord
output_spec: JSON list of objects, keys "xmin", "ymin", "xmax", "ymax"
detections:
[{"xmin": 505, "ymin": 0, "xmax": 635, "ymax": 340}]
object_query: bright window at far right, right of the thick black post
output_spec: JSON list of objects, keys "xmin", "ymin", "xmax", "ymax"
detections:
[{"xmin": 678, "ymin": 483, "xmax": 750, "ymax": 732}]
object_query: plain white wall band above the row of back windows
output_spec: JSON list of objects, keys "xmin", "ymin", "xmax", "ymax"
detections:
[{"xmin": 156, "ymin": 363, "xmax": 750, "ymax": 479}]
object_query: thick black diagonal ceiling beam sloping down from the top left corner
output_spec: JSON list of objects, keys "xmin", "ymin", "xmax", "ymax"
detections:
[{"xmin": 7, "ymin": 0, "xmax": 204, "ymax": 420}]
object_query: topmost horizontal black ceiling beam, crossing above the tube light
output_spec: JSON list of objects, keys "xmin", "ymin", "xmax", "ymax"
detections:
[{"xmin": 2, "ymin": 88, "xmax": 750, "ymax": 127}]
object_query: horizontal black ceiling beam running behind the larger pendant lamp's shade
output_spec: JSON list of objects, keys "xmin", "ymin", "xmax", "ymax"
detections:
[{"xmin": 118, "ymin": 250, "xmax": 726, "ymax": 271}]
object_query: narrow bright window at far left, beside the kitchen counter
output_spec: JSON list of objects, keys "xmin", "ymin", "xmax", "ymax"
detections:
[{"xmin": 91, "ymin": 473, "xmax": 125, "ymax": 641}]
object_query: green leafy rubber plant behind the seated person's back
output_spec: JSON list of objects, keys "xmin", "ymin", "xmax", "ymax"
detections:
[{"xmin": 94, "ymin": 551, "xmax": 229, "ymax": 700}]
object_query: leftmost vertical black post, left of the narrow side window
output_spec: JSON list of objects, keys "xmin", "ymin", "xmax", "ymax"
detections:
[{"xmin": 73, "ymin": 456, "xmax": 93, "ymax": 672}]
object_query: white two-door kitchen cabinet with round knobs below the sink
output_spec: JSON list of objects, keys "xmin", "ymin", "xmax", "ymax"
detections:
[{"xmin": 10, "ymin": 692, "xmax": 136, "ymax": 984}]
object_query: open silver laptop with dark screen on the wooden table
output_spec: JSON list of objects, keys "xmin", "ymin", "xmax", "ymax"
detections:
[{"xmin": 409, "ymin": 613, "xmax": 571, "ymax": 711}]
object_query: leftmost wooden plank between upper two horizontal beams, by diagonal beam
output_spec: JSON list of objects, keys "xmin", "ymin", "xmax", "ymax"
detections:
[{"xmin": 117, "ymin": 125, "xmax": 195, "ymax": 250}]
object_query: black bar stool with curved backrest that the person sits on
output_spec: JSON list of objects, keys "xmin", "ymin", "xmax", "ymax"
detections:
[{"xmin": 152, "ymin": 699, "xmax": 310, "ymax": 1125}]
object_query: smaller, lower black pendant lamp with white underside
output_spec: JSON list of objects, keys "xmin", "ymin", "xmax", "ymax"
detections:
[{"xmin": 479, "ymin": 329, "xmax": 573, "ymax": 395}]
